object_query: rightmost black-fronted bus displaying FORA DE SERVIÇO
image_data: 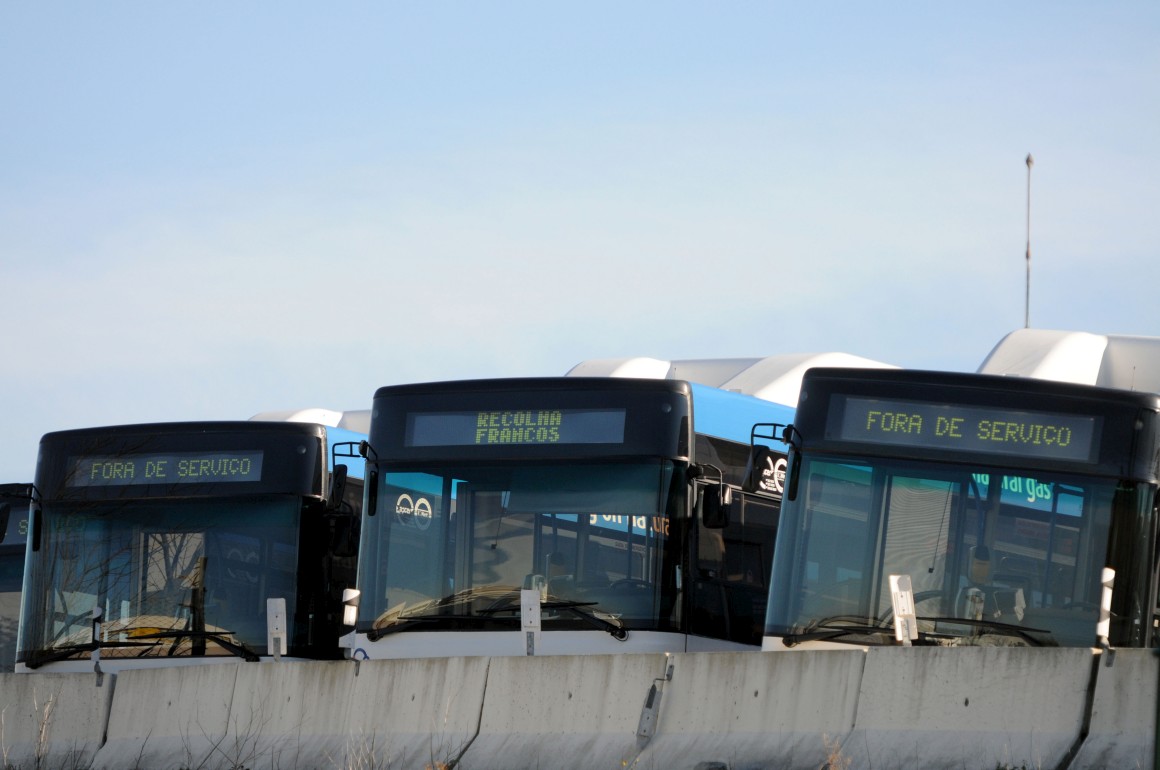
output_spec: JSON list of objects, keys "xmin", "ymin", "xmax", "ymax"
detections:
[{"xmin": 763, "ymin": 369, "xmax": 1160, "ymax": 649}]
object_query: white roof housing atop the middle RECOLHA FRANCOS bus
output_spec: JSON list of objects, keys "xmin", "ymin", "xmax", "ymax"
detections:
[{"xmin": 567, "ymin": 353, "xmax": 898, "ymax": 407}]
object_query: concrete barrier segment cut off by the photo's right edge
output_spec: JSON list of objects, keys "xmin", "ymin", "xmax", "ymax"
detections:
[{"xmin": 1072, "ymin": 649, "xmax": 1160, "ymax": 768}]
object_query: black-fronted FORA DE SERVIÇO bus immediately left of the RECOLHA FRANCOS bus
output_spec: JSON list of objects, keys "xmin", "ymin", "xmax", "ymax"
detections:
[{"xmin": 16, "ymin": 421, "xmax": 363, "ymax": 671}]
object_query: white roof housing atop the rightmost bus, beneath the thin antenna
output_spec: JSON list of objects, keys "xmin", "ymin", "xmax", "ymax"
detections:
[{"xmin": 979, "ymin": 329, "xmax": 1160, "ymax": 393}]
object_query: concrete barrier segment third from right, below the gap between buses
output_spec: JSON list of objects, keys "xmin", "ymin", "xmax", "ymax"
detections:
[{"xmin": 637, "ymin": 648, "xmax": 867, "ymax": 770}]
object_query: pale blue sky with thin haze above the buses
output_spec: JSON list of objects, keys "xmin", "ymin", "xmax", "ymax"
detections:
[{"xmin": 0, "ymin": 1, "xmax": 1160, "ymax": 481}]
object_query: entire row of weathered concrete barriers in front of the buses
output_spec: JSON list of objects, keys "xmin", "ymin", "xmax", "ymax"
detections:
[{"xmin": 0, "ymin": 647, "xmax": 1160, "ymax": 770}]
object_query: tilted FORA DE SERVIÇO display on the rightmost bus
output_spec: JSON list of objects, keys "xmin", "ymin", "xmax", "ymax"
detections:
[{"xmin": 831, "ymin": 395, "xmax": 1099, "ymax": 463}]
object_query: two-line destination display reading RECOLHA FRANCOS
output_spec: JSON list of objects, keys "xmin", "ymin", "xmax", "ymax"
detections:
[{"xmin": 404, "ymin": 409, "xmax": 625, "ymax": 446}]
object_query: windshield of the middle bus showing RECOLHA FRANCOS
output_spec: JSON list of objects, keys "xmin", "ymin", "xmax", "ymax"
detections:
[{"xmin": 358, "ymin": 460, "xmax": 683, "ymax": 638}]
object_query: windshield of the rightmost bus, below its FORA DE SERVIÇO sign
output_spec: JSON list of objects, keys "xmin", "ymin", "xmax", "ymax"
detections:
[{"xmin": 766, "ymin": 457, "xmax": 1136, "ymax": 646}]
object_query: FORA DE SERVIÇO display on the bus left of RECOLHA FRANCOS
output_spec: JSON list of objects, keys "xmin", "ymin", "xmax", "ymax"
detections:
[{"xmin": 67, "ymin": 451, "xmax": 263, "ymax": 487}]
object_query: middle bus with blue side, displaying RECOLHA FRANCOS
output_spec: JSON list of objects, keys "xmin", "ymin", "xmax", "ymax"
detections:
[{"xmin": 343, "ymin": 377, "xmax": 792, "ymax": 660}]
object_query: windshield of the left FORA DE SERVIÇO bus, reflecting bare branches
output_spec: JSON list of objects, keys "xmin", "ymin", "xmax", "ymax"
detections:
[{"xmin": 20, "ymin": 496, "xmax": 299, "ymax": 667}]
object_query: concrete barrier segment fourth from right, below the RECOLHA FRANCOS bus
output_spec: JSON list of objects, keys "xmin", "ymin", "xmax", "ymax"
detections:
[{"xmin": 458, "ymin": 654, "xmax": 667, "ymax": 770}]
